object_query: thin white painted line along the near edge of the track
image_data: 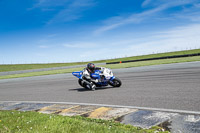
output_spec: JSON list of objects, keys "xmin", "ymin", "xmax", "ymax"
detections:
[{"xmin": 0, "ymin": 101, "xmax": 200, "ymax": 115}]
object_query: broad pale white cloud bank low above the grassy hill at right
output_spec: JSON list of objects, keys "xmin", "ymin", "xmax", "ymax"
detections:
[{"xmin": 86, "ymin": 24, "xmax": 200, "ymax": 60}]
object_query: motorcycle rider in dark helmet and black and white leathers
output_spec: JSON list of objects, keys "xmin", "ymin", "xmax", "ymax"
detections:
[{"xmin": 82, "ymin": 63, "xmax": 104, "ymax": 90}]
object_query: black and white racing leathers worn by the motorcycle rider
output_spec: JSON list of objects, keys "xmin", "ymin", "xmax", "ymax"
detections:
[{"xmin": 81, "ymin": 67, "xmax": 105, "ymax": 90}]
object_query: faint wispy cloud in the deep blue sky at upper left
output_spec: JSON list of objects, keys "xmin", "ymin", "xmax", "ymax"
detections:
[{"xmin": 28, "ymin": 0, "xmax": 95, "ymax": 25}]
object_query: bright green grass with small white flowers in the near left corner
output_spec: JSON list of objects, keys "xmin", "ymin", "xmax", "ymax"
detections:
[{"xmin": 0, "ymin": 111, "xmax": 164, "ymax": 133}]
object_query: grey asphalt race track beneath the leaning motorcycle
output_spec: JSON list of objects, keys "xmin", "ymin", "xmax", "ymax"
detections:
[{"xmin": 0, "ymin": 62, "xmax": 200, "ymax": 112}]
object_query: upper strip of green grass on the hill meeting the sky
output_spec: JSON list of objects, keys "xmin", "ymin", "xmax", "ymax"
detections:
[{"xmin": 0, "ymin": 49, "xmax": 200, "ymax": 72}]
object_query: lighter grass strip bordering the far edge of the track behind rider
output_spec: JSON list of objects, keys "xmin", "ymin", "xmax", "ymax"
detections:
[{"xmin": 0, "ymin": 56, "xmax": 200, "ymax": 79}]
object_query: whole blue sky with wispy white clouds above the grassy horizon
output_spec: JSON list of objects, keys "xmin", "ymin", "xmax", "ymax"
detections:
[{"xmin": 0, "ymin": 0, "xmax": 200, "ymax": 64}]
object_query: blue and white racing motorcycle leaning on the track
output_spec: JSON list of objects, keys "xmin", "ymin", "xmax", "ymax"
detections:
[{"xmin": 72, "ymin": 68, "xmax": 122, "ymax": 89}]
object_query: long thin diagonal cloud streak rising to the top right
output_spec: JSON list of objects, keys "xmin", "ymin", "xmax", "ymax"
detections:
[{"xmin": 94, "ymin": 0, "xmax": 196, "ymax": 35}]
